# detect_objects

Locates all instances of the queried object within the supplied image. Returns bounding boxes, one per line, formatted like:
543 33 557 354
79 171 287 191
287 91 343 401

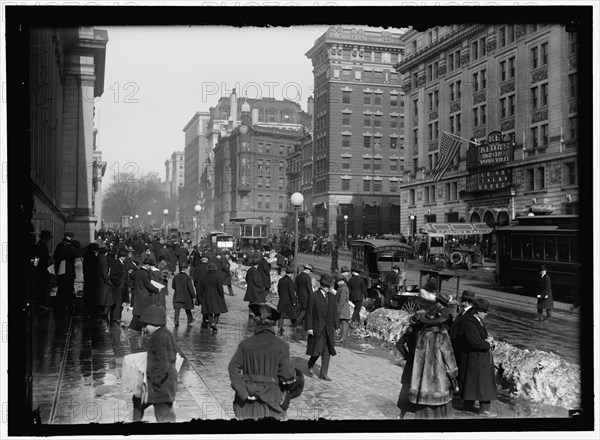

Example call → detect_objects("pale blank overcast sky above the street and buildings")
96 26 338 184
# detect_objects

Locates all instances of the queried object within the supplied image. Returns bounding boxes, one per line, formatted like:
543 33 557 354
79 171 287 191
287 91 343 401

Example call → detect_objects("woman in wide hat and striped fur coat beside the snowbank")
397 311 458 419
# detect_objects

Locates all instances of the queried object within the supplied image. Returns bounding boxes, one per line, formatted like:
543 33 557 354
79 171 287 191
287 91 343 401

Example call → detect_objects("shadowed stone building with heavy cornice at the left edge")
29 26 108 247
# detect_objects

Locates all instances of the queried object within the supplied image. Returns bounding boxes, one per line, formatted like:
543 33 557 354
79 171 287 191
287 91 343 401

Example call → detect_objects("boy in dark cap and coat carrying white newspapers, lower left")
133 304 177 423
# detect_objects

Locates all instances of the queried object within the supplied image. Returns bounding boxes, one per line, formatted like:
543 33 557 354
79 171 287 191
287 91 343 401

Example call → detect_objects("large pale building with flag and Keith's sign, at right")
396 24 579 237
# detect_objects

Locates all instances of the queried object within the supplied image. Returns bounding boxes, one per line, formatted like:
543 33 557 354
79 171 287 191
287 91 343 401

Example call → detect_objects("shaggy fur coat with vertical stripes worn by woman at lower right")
408 325 458 406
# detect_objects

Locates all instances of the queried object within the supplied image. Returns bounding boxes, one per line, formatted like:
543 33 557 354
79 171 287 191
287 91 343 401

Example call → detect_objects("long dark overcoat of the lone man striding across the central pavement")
304 289 340 356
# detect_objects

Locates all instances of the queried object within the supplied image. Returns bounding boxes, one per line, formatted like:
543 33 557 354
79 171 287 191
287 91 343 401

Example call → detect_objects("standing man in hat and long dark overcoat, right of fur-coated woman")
459 298 498 417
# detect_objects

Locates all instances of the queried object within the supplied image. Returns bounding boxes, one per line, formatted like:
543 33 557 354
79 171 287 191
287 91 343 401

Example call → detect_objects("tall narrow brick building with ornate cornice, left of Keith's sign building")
304 26 404 239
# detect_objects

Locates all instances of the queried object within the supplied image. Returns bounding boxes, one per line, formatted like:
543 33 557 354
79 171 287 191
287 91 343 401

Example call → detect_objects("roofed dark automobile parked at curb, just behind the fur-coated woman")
390 269 460 316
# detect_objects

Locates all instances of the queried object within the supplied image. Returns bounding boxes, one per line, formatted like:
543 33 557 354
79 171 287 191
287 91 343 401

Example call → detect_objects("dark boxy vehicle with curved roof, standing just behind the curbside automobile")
351 240 413 309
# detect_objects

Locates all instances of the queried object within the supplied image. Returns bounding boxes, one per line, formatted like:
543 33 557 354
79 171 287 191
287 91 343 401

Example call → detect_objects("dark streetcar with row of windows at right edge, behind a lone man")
495 215 581 303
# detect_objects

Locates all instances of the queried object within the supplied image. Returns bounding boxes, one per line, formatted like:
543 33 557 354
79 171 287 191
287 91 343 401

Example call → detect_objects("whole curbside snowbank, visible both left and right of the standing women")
361 308 581 409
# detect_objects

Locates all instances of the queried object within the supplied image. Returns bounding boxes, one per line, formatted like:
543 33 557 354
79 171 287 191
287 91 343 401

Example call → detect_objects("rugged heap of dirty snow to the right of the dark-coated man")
493 341 581 408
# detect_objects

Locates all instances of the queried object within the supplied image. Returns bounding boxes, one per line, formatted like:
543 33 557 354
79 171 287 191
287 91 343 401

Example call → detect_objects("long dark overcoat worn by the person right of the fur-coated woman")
459 315 498 401
